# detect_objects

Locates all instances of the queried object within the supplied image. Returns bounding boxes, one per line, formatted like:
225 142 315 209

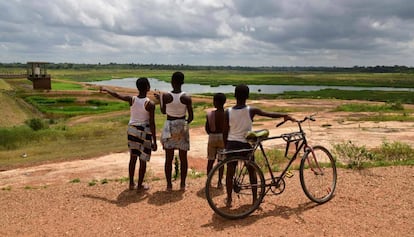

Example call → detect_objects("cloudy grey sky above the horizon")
0 0 414 67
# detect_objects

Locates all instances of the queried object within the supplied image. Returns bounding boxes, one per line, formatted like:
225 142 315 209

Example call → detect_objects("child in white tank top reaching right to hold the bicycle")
223 84 296 207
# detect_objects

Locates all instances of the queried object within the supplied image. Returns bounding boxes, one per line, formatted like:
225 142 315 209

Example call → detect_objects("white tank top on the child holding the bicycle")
227 106 253 142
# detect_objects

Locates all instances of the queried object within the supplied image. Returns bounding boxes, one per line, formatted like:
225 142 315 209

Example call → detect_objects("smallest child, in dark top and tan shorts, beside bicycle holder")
205 93 226 188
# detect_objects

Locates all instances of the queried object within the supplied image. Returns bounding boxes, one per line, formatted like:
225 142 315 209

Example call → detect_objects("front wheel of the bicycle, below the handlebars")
300 146 336 203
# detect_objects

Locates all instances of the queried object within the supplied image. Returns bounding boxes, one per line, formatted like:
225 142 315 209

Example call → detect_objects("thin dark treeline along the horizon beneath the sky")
0 63 414 73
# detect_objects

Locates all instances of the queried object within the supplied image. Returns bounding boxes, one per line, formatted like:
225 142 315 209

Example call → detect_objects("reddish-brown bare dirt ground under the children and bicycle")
0 100 414 236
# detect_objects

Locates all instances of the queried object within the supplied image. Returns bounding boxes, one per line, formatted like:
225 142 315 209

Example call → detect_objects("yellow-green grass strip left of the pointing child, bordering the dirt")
0 122 128 169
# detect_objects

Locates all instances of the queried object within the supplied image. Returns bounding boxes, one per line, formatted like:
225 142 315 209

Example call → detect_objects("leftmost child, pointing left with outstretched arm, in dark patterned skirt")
101 77 157 191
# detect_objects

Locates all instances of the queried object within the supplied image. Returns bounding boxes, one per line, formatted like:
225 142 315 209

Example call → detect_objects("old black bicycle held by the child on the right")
205 115 337 219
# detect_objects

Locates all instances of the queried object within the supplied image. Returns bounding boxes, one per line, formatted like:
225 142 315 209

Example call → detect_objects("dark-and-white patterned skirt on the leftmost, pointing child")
127 124 152 161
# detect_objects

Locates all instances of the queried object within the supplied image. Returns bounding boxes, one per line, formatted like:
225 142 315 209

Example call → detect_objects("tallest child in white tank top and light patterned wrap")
156 72 194 191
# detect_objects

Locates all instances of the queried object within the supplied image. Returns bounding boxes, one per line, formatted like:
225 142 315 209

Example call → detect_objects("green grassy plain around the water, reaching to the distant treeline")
0 66 414 170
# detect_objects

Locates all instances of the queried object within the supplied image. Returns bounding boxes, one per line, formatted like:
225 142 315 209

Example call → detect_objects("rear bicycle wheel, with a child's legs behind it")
205 157 265 219
